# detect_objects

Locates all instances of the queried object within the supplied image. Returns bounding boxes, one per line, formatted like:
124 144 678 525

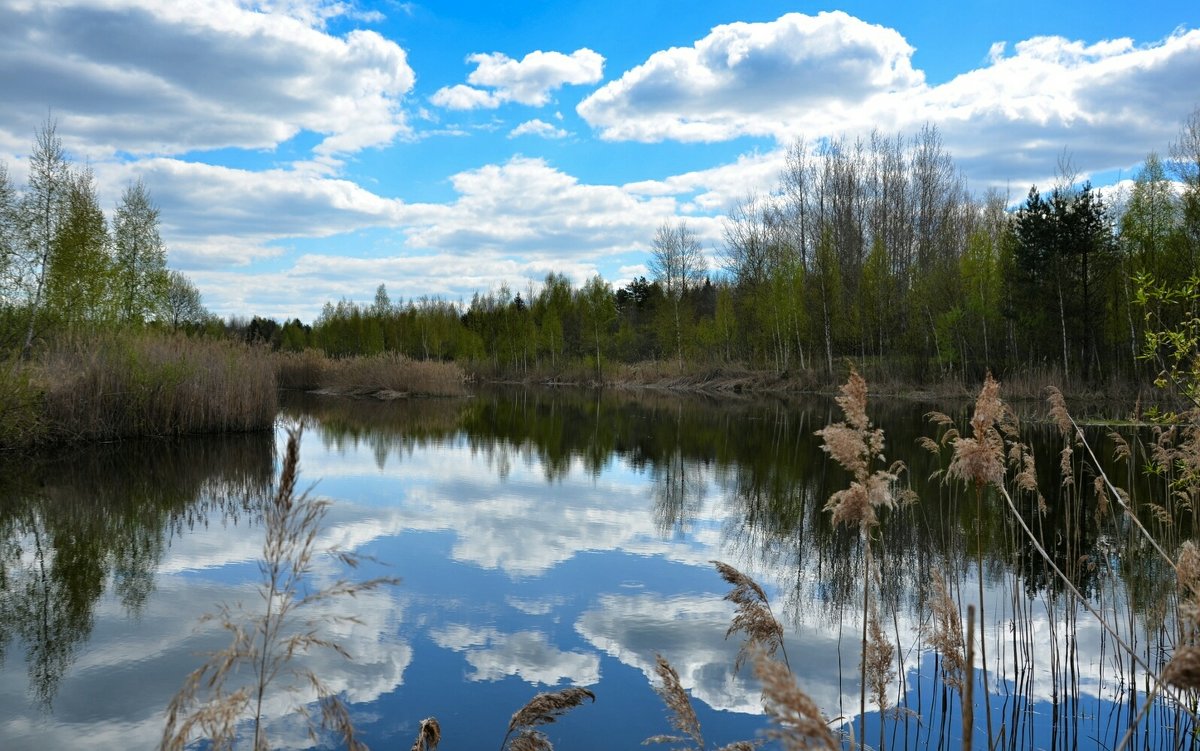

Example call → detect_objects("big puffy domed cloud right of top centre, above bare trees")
577 11 923 140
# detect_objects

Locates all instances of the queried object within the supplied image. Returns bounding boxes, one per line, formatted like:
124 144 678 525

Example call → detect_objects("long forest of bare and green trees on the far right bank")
257 109 1200 380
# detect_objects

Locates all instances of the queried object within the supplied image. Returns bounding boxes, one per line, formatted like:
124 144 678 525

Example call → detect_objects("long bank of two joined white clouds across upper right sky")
577 12 1200 187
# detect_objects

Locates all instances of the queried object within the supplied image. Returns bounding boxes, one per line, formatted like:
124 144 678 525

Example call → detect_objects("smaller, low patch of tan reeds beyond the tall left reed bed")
275 349 467 398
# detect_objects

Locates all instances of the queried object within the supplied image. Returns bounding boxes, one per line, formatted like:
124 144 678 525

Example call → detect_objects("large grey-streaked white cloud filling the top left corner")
0 0 414 158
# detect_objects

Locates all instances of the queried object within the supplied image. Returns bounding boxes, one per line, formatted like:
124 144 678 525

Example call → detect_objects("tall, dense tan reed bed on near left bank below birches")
0 332 278 449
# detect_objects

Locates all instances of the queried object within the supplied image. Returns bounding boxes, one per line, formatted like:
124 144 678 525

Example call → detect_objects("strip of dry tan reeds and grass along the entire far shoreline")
0 328 1177 450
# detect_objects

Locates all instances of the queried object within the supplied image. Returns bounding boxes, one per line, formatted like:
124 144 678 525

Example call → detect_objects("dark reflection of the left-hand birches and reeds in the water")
0 435 274 705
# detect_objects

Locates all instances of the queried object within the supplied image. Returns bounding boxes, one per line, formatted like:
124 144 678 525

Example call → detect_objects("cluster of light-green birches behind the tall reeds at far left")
0 121 209 356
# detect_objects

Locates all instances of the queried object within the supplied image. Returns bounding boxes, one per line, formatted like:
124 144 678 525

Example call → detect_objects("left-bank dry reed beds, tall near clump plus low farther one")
0 331 467 450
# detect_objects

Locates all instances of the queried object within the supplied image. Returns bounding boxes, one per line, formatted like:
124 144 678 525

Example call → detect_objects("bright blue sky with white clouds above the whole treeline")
0 0 1200 320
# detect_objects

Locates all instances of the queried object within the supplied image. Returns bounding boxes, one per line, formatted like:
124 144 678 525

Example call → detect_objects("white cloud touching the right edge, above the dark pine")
912 31 1200 185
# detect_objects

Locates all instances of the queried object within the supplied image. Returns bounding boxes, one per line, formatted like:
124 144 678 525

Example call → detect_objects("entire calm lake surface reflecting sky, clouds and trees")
0 389 1193 751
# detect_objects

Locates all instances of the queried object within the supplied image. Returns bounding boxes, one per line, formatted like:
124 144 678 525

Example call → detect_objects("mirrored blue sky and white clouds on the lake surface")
0 412 1185 750
